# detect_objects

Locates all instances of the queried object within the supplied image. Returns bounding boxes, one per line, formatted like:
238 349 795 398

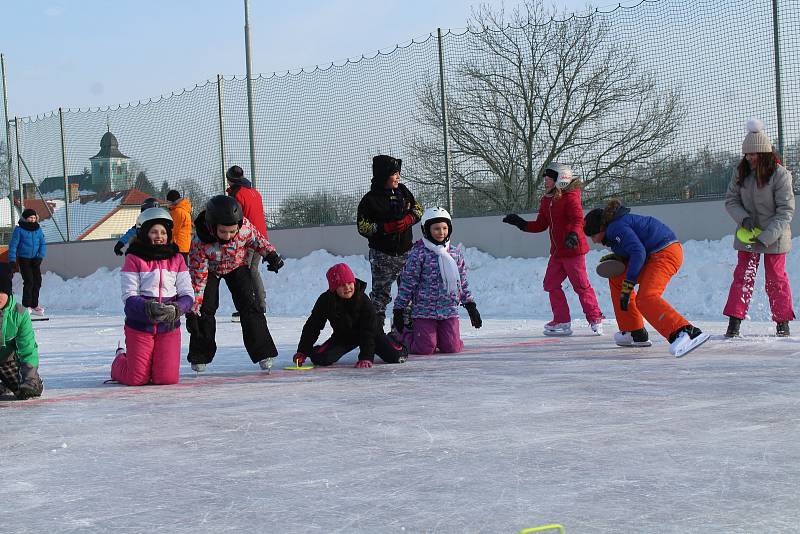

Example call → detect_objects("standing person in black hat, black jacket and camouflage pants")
357 155 423 330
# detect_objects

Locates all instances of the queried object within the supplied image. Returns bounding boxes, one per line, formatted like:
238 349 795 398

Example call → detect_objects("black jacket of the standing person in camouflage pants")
357 182 422 256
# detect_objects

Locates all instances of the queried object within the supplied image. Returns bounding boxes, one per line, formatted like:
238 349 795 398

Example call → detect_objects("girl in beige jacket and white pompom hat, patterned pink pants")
723 120 794 337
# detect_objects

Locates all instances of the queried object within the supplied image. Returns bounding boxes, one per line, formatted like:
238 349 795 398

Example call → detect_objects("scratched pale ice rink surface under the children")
0 315 800 534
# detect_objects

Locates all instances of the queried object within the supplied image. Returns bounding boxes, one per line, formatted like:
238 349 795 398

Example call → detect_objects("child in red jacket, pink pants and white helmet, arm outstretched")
503 163 603 336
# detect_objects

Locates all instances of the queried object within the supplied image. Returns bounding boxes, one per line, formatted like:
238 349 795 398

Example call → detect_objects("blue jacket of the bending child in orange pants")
603 206 678 283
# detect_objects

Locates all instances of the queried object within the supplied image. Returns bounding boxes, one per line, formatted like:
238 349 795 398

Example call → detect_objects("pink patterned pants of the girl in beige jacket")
722 251 794 322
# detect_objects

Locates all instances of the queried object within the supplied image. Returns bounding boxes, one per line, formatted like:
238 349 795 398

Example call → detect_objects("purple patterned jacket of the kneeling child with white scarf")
394 239 473 320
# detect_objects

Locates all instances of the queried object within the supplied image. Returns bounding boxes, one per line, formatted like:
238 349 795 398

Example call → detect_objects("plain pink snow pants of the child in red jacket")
543 254 603 323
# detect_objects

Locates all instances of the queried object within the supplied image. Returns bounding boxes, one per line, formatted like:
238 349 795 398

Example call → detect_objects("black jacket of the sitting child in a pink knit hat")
297 278 377 361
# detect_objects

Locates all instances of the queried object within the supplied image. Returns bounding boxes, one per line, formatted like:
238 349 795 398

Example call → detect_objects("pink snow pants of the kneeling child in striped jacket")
111 326 181 386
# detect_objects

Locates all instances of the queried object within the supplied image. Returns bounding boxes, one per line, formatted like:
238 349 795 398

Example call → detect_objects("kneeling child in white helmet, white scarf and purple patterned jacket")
394 208 483 354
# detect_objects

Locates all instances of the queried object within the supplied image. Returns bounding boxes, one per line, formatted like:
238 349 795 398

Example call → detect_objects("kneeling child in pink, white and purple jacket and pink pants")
111 208 194 386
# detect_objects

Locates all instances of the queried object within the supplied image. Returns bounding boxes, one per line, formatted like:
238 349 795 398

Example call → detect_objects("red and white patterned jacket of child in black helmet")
189 211 276 313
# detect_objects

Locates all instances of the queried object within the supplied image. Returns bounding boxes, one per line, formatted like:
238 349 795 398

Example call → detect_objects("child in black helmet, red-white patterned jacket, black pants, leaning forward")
186 195 283 372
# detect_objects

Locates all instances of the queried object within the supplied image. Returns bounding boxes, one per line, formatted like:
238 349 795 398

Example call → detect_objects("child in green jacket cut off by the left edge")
0 263 43 399
